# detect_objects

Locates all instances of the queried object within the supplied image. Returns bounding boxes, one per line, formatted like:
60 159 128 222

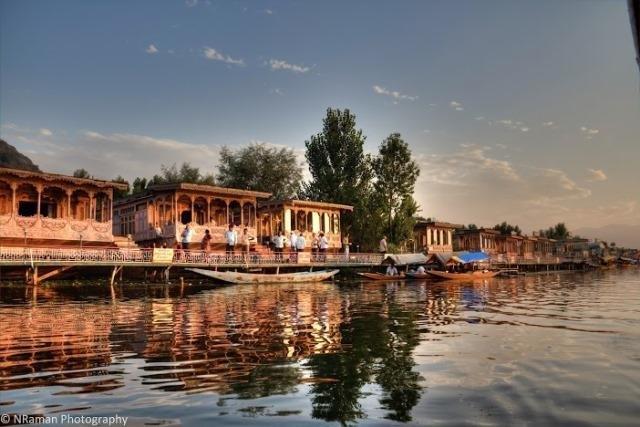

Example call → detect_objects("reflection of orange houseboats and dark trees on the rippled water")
0 283 470 424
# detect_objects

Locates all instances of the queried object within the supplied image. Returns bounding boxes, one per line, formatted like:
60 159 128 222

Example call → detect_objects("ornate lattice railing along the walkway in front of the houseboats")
0 247 382 266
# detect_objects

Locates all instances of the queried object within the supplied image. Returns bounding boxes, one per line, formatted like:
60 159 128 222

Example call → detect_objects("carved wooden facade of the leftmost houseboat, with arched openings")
0 168 127 246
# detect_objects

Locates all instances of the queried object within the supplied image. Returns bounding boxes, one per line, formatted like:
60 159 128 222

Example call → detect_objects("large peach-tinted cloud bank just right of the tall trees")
415 144 591 229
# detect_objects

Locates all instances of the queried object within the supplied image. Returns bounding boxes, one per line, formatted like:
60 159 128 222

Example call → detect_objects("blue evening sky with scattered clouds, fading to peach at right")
0 0 640 246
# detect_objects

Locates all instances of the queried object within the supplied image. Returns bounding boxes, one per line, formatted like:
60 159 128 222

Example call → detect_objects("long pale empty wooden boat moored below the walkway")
187 268 340 284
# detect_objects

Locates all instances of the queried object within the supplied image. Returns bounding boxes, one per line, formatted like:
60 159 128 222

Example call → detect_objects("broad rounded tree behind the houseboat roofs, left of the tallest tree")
217 144 302 199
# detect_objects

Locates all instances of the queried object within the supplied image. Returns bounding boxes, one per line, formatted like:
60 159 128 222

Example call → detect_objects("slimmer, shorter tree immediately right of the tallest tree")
373 133 420 244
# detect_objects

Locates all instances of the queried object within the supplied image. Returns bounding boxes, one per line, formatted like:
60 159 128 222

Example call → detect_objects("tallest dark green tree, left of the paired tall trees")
304 108 380 249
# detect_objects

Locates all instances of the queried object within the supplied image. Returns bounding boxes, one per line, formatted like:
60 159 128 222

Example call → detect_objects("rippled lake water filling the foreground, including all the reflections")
0 269 640 426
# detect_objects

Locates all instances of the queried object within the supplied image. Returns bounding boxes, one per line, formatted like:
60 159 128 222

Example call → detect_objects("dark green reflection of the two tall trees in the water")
307 303 421 425
